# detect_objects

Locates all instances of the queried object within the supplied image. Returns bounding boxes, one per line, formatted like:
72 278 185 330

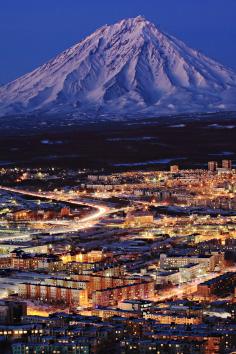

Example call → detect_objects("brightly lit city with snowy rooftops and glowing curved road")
0 162 236 354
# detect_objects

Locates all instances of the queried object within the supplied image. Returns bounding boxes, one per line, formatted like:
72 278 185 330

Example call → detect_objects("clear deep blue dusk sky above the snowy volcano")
0 0 236 83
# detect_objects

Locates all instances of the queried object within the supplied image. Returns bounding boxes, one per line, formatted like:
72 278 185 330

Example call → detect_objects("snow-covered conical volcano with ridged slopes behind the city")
0 16 236 115
